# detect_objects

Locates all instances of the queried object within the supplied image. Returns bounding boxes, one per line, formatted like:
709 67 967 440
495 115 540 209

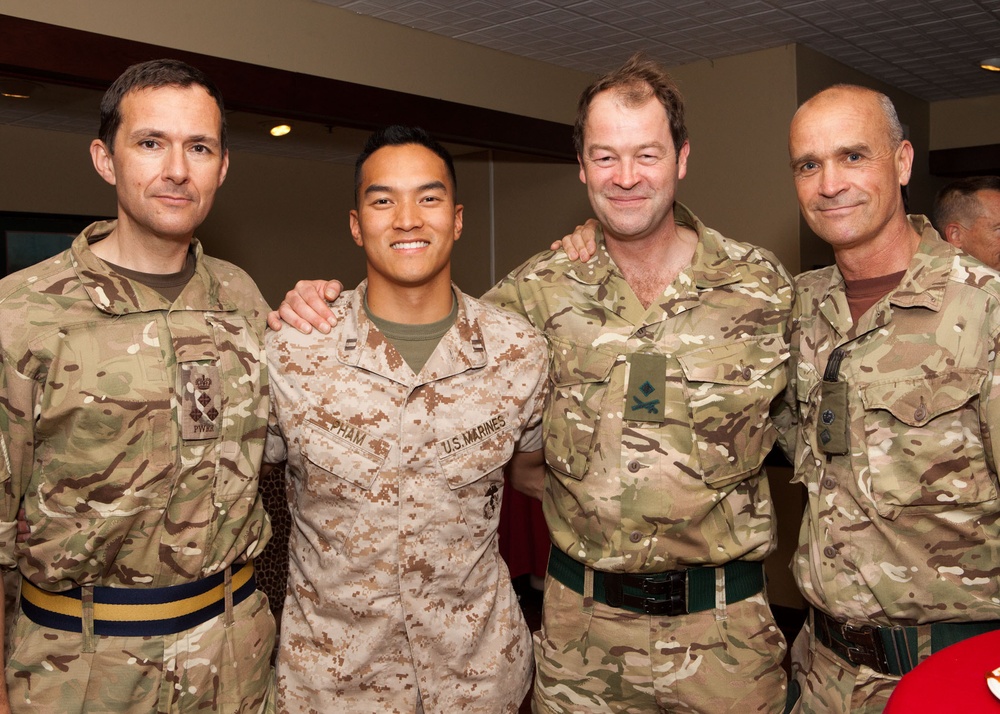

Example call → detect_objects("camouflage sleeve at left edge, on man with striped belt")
0 346 37 567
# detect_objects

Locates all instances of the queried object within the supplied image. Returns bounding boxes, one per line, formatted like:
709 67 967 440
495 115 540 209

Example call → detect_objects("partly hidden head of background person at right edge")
933 176 1000 270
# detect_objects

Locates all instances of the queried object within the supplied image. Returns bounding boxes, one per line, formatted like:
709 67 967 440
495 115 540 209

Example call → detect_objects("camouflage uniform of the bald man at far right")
778 216 1000 712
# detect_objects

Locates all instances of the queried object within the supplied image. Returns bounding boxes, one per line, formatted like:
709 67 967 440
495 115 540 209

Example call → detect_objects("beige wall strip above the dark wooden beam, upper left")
0 0 592 123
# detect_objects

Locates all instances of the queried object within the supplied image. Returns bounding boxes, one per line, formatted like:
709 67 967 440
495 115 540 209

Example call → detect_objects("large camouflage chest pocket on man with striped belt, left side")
35 318 177 518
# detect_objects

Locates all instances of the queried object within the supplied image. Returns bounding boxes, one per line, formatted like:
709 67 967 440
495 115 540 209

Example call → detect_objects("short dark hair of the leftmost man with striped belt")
97 59 228 154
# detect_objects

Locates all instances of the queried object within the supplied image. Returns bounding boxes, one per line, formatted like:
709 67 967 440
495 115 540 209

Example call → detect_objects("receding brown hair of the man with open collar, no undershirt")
573 52 687 157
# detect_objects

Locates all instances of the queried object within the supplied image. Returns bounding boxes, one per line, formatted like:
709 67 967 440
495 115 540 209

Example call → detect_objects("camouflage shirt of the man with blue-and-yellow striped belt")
0 221 270 590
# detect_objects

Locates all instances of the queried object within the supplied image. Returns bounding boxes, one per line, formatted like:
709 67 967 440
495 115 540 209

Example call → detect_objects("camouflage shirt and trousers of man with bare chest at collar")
486 203 793 714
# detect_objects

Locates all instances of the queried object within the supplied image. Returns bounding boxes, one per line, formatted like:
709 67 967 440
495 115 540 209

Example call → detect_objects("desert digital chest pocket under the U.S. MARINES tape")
440 429 515 548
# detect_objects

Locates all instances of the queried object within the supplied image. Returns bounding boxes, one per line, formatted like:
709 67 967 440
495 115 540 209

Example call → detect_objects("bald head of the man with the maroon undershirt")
788 85 913 263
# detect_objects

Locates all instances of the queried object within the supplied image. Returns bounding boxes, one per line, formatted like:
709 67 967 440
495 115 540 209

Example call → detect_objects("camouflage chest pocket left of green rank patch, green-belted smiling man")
545 337 618 480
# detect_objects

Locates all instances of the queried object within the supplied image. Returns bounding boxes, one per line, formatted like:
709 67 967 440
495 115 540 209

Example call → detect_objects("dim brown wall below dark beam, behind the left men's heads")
0 125 589 305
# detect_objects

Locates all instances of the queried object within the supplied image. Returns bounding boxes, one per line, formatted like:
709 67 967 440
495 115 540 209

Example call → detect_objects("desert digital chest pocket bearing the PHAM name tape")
292 421 388 553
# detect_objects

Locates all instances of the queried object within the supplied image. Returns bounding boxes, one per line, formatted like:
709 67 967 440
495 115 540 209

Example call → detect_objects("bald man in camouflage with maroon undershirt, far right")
779 86 1000 714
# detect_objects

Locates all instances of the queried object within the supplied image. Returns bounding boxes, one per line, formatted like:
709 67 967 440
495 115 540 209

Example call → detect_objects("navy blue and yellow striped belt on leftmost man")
21 561 257 637
